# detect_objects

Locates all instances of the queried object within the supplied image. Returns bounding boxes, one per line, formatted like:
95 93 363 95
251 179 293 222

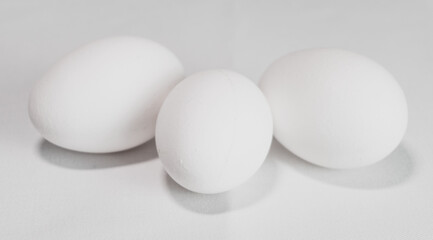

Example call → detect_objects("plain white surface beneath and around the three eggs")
0 0 433 240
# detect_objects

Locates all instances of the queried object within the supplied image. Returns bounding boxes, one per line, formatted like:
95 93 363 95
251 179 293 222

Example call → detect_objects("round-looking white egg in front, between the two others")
155 70 272 193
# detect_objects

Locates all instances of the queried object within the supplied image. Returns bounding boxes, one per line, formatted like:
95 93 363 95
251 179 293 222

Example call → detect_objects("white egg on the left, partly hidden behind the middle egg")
28 36 184 153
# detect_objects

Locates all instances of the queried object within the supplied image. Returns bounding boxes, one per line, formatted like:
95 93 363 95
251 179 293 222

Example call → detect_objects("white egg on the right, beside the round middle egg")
260 49 408 169
